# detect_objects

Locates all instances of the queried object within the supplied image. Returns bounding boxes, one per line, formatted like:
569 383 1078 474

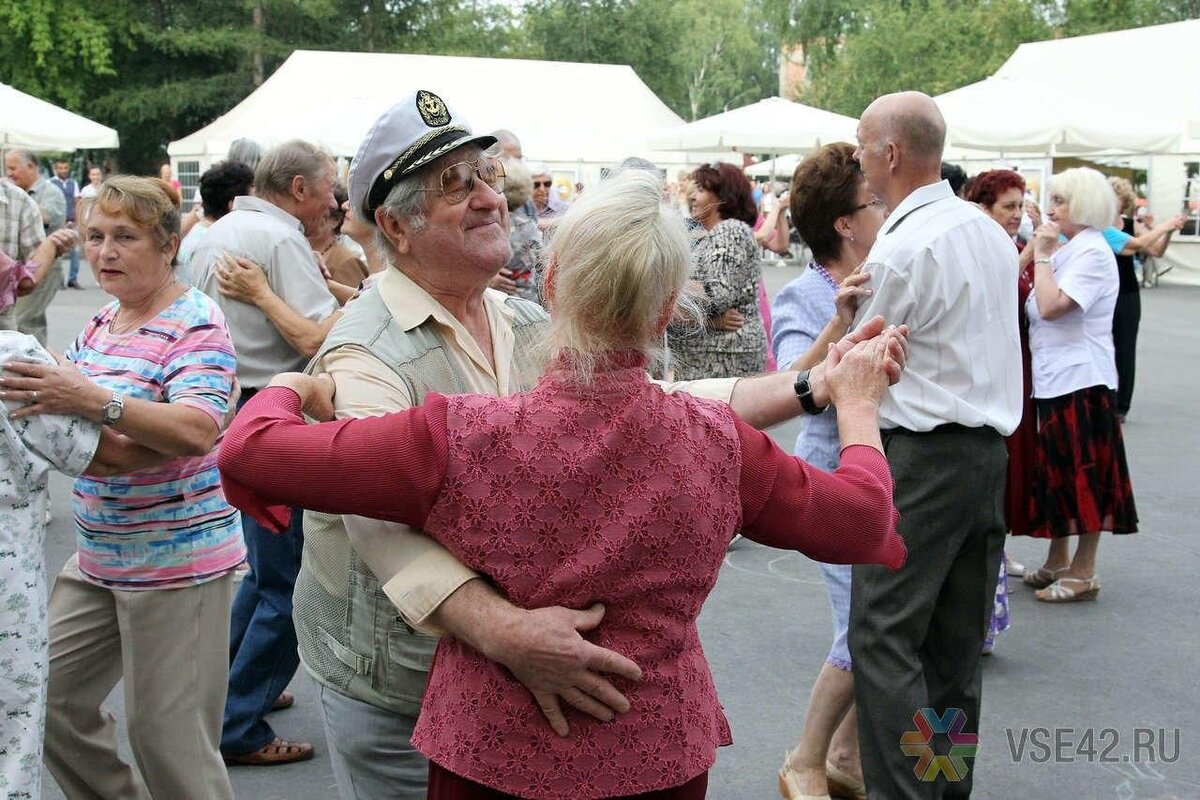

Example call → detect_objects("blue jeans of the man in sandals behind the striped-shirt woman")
221 509 304 756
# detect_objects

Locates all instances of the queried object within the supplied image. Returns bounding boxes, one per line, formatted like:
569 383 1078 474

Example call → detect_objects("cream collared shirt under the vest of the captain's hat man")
320 269 737 633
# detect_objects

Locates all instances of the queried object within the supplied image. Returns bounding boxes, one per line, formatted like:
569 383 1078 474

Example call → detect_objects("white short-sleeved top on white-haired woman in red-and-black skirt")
1025 228 1121 398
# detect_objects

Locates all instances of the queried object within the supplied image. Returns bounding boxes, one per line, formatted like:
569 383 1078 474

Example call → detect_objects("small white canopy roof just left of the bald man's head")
650 97 858 154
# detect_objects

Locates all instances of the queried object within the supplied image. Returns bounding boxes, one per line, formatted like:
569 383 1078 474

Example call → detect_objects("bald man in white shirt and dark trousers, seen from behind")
850 92 1021 800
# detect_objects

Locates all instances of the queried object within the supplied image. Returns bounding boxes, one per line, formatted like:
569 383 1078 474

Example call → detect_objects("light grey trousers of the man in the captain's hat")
317 684 430 800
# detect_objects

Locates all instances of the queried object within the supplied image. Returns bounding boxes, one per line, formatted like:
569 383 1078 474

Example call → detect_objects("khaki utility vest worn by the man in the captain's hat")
293 289 550 717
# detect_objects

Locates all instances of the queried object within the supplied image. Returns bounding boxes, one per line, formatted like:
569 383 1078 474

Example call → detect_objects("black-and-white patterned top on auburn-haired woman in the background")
667 219 767 380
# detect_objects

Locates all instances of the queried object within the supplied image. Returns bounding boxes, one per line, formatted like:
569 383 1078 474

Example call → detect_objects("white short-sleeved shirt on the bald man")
856 181 1021 435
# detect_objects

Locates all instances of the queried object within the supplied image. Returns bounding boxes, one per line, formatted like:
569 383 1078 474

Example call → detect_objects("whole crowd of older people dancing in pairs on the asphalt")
0 82 1161 800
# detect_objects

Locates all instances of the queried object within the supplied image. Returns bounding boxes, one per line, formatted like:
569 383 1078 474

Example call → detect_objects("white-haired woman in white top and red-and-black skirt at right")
1025 167 1138 603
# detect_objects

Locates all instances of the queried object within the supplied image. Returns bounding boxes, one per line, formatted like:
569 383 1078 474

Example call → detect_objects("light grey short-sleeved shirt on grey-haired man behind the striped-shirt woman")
188 196 337 389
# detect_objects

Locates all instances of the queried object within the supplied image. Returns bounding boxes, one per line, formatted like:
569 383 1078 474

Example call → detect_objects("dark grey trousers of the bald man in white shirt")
850 426 1008 800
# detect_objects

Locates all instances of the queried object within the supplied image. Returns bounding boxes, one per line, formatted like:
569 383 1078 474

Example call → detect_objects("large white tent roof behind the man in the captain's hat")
174 50 682 164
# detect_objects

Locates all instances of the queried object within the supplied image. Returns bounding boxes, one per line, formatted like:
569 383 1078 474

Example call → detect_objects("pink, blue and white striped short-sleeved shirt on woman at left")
67 288 245 590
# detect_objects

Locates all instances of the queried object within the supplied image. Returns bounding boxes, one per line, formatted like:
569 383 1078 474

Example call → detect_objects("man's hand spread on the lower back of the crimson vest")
488 603 642 736
